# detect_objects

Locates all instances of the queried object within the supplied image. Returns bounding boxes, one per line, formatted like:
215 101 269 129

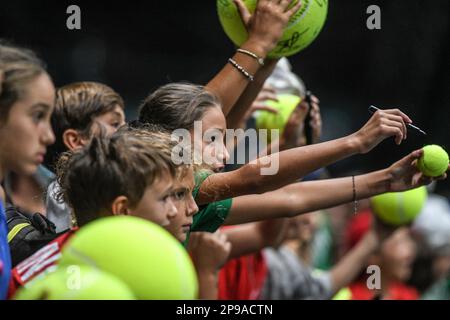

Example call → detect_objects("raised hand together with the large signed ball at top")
217 0 328 58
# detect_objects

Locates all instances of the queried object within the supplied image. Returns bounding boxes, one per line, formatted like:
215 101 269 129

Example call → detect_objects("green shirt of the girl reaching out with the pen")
185 171 232 245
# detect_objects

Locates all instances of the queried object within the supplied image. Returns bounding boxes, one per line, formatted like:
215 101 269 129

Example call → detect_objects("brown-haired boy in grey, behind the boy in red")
45 82 125 232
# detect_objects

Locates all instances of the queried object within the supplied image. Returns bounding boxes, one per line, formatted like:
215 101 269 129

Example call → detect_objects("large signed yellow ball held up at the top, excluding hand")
217 0 328 58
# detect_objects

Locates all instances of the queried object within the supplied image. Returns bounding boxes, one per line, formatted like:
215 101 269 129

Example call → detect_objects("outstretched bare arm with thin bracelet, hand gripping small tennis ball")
225 149 446 225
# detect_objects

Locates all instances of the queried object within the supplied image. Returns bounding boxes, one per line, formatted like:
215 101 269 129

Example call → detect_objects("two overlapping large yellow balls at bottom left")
15 216 198 300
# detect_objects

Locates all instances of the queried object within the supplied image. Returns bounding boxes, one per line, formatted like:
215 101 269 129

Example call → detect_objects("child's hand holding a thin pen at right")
354 109 412 153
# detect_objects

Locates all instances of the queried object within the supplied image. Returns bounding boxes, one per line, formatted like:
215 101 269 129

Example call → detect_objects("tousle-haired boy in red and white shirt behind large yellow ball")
13 128 229 300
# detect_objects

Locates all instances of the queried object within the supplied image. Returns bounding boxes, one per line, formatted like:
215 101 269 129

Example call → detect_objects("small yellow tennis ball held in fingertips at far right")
417 144 449 177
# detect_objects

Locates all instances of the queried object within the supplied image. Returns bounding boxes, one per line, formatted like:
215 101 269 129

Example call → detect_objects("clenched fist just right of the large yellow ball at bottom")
188 231 231 274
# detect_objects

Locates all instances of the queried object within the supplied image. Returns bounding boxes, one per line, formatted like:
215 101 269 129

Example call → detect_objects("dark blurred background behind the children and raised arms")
0 0 450 191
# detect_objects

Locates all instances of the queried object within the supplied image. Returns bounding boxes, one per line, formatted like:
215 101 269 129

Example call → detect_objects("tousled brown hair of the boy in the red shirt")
57 128 183 226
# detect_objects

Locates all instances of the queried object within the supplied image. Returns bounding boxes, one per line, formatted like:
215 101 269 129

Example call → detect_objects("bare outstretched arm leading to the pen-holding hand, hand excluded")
195 136 358 205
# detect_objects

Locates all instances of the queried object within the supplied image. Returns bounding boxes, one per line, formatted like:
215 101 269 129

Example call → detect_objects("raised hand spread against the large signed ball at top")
234 0 301 56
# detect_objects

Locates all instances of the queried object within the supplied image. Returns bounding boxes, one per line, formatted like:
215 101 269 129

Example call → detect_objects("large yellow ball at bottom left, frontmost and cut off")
15 265 135 300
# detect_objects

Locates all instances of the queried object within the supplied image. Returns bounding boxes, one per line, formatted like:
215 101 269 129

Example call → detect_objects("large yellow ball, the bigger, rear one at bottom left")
59 216 198 300
